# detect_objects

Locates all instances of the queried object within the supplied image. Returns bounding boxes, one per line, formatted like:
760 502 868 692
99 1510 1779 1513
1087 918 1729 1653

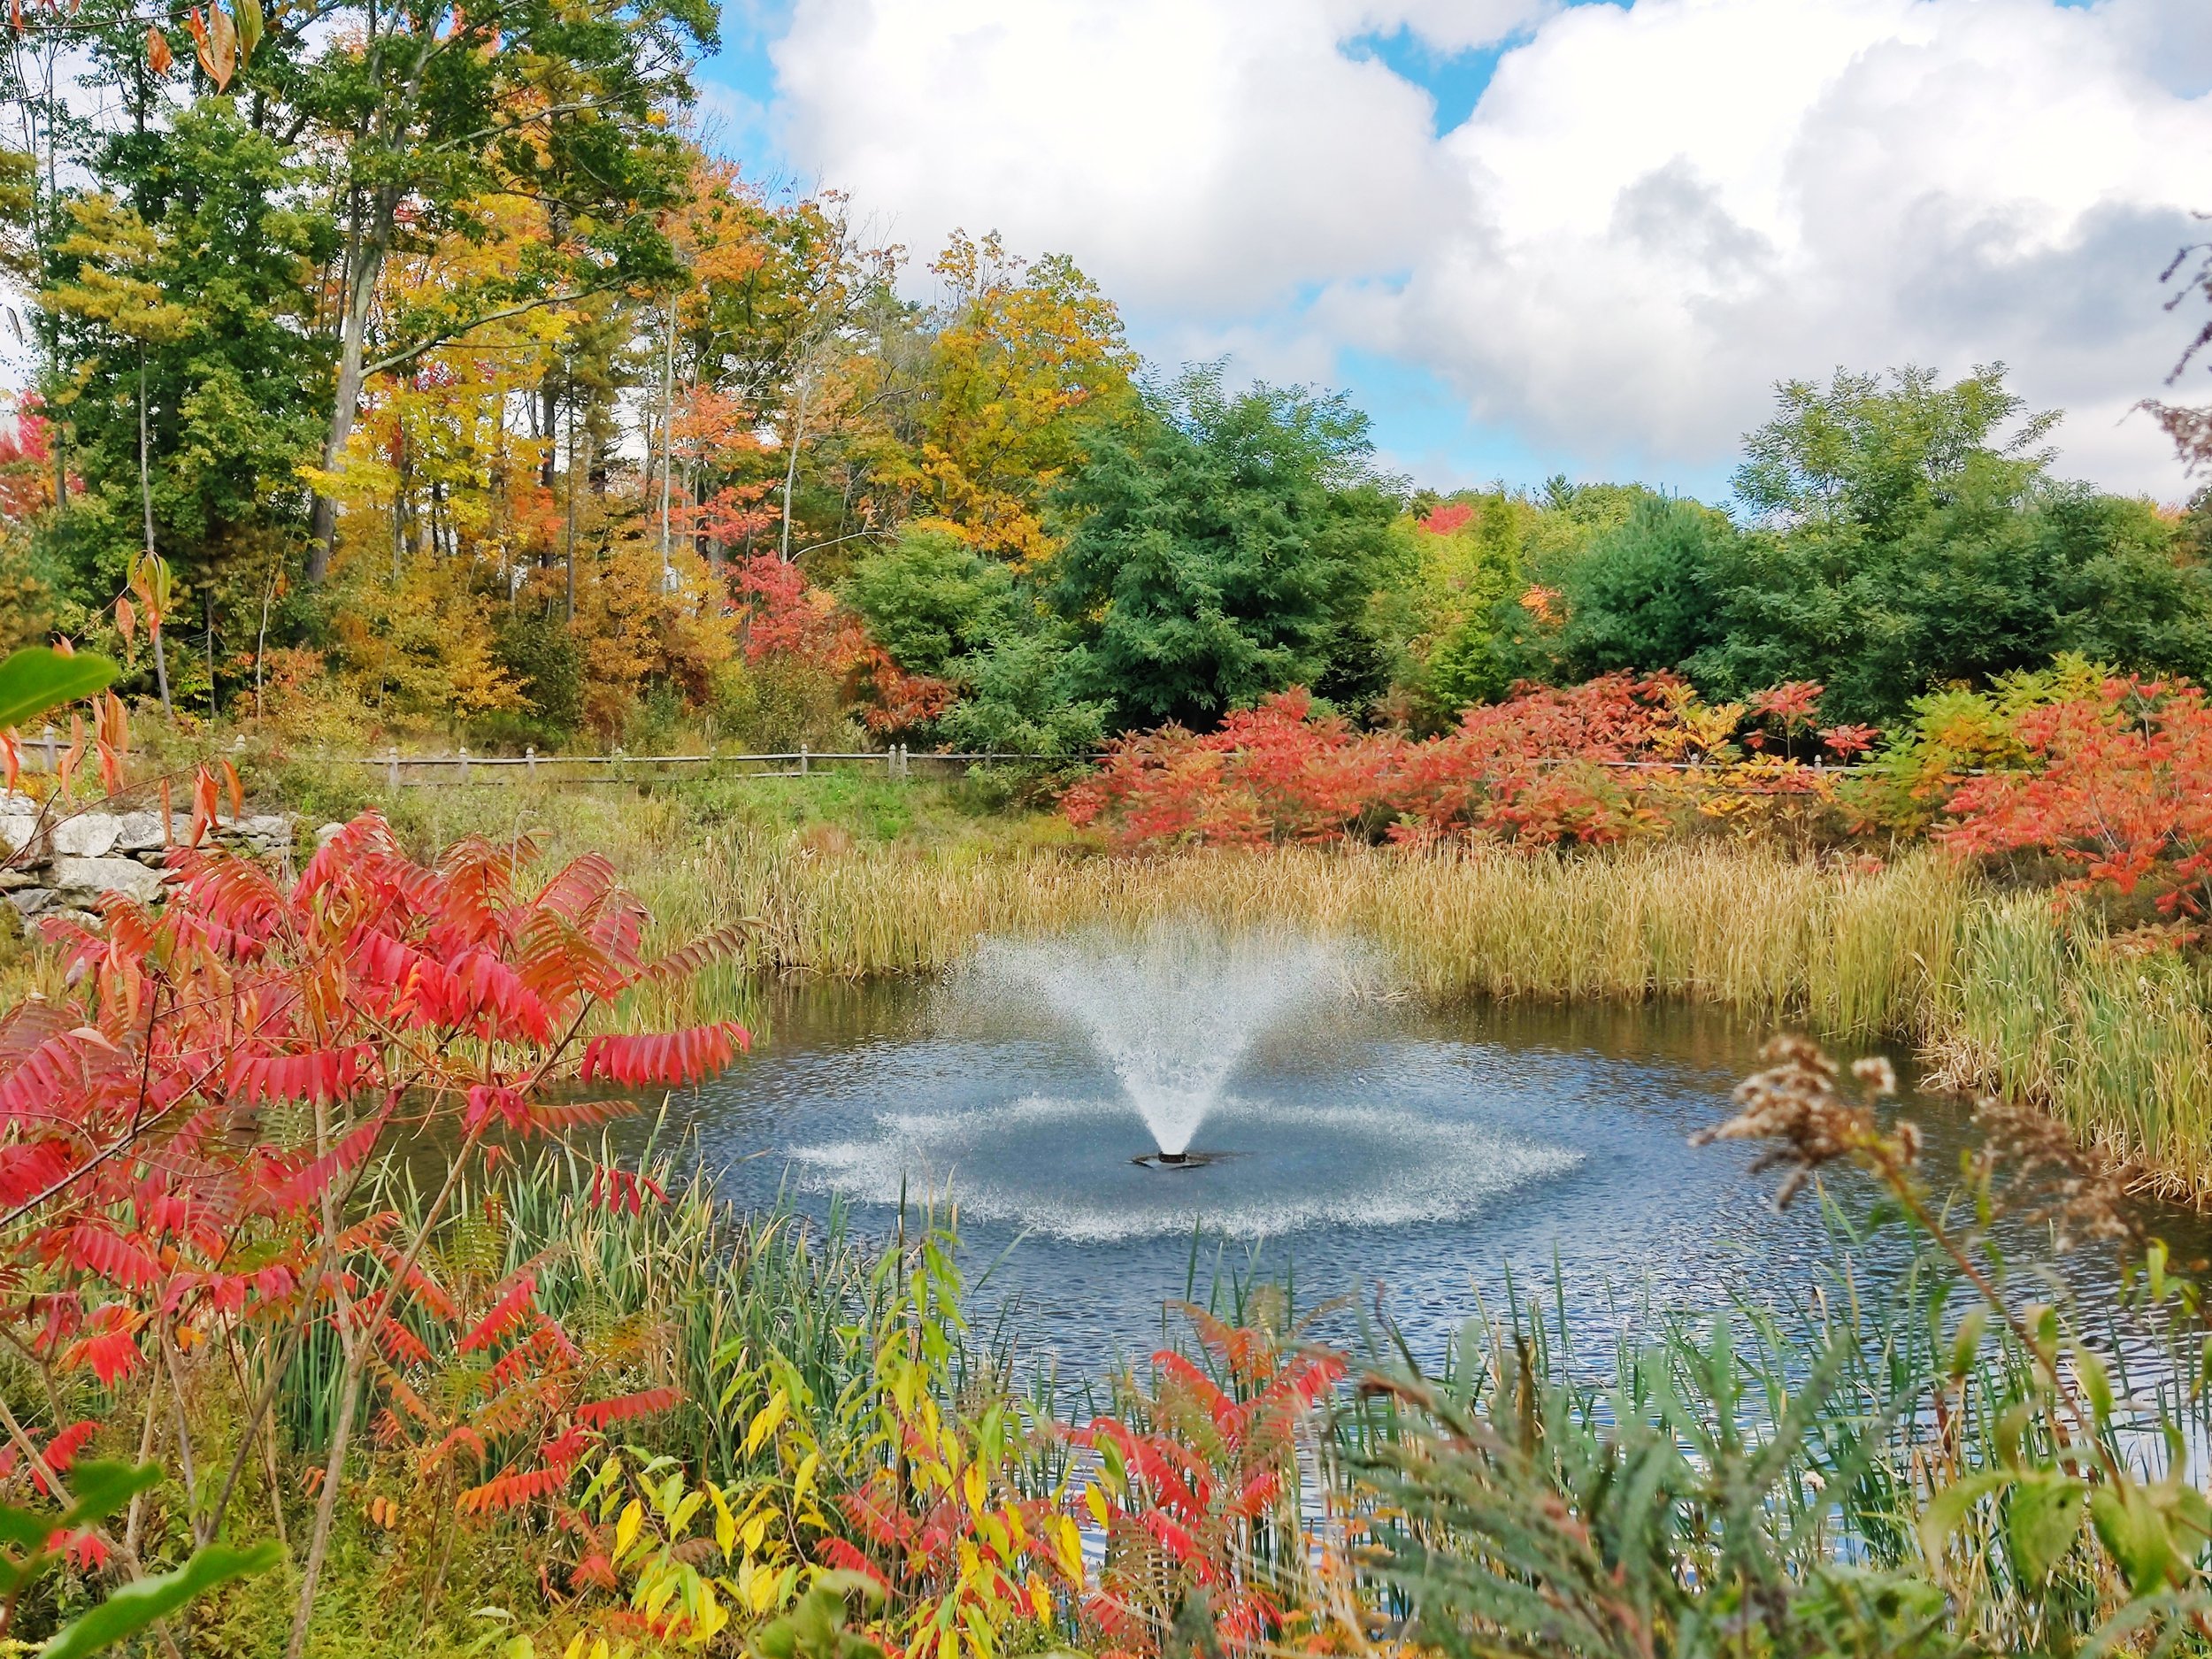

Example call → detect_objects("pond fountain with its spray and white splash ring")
781 925 1579 1241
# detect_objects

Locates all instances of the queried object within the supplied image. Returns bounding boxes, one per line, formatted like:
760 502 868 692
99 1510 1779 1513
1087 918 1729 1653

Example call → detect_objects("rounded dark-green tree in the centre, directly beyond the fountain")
1047 367 1398 730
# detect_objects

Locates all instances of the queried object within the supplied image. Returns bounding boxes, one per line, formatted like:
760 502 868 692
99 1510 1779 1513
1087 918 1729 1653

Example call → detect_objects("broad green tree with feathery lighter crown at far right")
1690 367 2212 724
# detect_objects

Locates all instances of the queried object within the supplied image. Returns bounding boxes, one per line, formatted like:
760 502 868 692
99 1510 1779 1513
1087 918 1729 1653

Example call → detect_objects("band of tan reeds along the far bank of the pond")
372 786 2212 1199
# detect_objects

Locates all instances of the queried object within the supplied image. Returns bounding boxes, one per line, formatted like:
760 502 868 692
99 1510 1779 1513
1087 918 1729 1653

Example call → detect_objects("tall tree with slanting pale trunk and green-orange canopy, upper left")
270 0 715 580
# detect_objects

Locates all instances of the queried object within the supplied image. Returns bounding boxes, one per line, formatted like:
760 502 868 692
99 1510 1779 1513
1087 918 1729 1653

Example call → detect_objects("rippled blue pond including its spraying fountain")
646 941 2206 1374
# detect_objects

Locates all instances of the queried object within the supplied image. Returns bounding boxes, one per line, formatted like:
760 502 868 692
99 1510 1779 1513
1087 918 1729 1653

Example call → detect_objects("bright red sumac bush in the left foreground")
0 814 743 1653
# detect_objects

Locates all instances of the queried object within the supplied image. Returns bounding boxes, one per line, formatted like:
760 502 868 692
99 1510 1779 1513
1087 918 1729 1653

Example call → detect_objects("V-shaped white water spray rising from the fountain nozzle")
976 925 1361 1168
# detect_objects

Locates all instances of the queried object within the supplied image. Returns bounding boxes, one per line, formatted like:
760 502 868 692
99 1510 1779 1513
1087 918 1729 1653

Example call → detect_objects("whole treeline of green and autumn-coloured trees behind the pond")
0 0 2212 755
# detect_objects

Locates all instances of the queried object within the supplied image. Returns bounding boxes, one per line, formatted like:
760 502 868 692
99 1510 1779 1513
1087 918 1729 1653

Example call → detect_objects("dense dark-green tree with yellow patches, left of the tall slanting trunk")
42 97 336 650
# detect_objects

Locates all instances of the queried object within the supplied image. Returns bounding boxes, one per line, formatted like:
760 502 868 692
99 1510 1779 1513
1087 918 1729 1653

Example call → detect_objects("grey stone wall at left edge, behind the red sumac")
0 792 296 920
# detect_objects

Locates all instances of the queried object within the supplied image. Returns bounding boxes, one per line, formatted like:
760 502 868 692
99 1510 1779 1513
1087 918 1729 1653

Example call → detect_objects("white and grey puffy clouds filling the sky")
774 0 2212 495
